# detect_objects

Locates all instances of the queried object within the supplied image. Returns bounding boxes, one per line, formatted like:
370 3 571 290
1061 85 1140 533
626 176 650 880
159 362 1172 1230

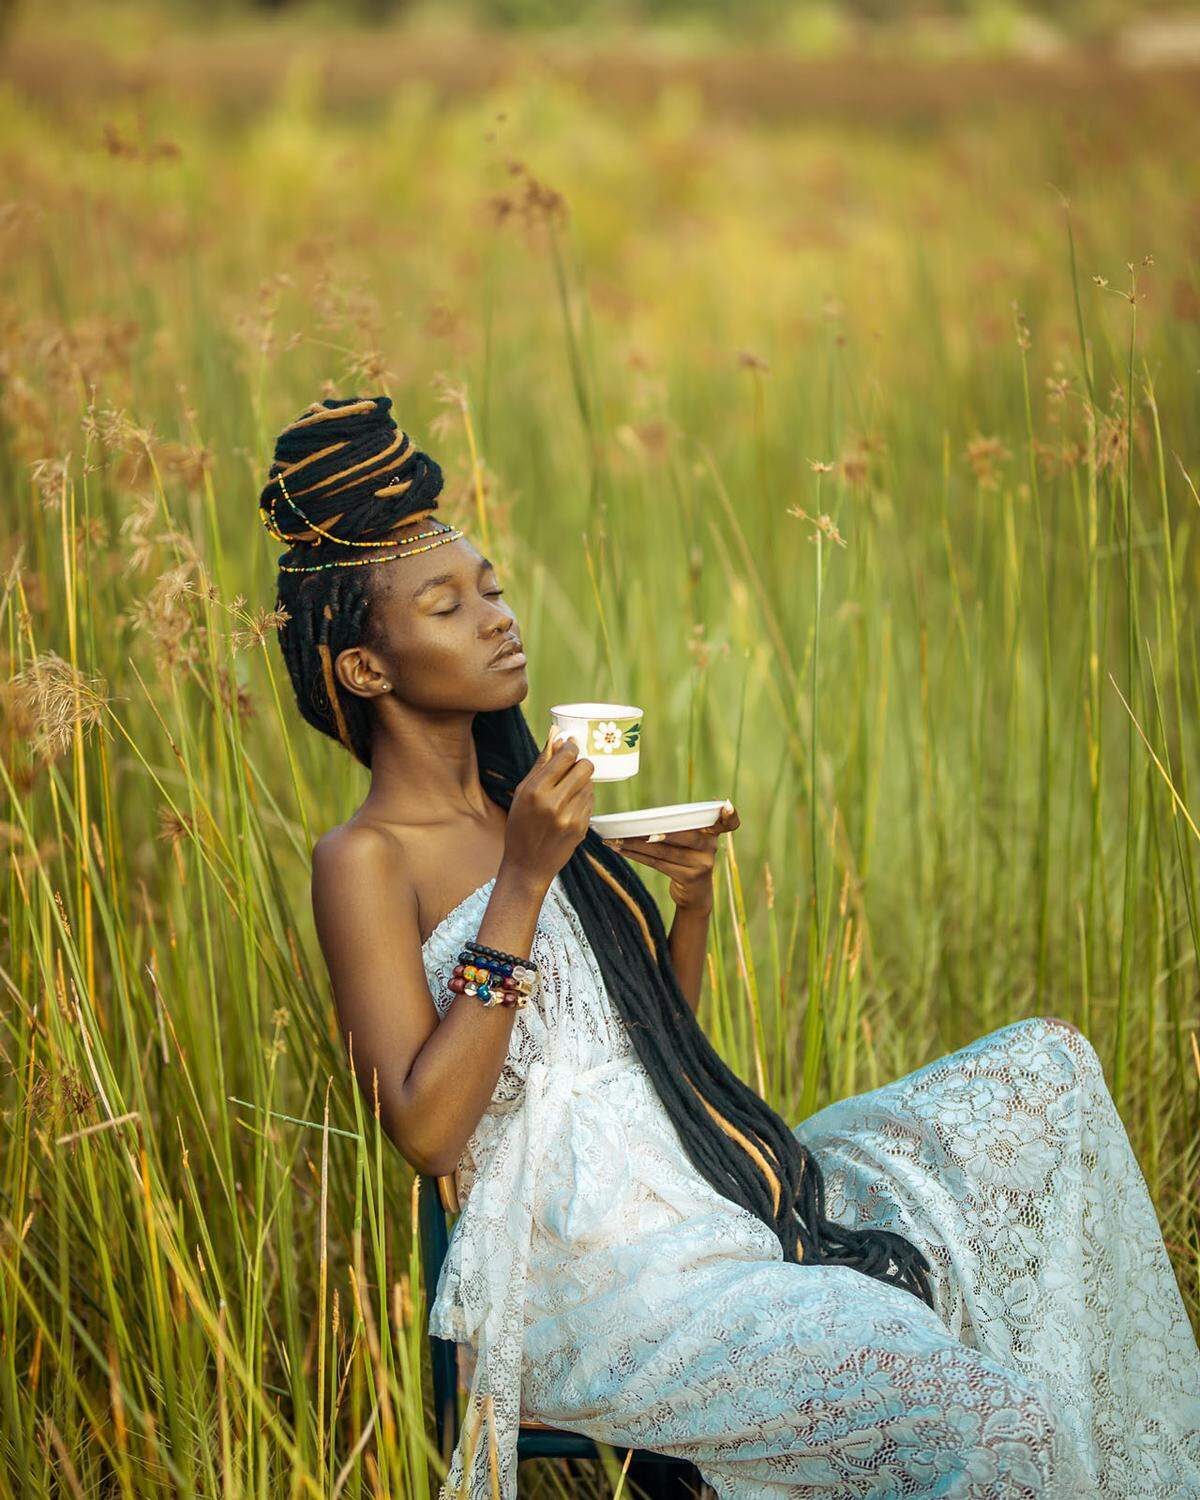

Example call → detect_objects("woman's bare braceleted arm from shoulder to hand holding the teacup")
312 740 594 1176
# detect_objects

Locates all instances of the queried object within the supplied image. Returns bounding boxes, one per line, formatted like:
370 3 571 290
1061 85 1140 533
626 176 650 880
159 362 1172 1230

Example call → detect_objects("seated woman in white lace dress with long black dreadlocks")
261 398 1200 1500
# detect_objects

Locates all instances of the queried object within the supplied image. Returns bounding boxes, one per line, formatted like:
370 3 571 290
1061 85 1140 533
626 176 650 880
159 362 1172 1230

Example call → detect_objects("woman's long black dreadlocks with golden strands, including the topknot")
260 396 933 1307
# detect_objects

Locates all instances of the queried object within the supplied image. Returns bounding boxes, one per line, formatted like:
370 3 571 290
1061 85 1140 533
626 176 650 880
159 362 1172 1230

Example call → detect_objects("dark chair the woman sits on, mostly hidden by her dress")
419 1175 704 1500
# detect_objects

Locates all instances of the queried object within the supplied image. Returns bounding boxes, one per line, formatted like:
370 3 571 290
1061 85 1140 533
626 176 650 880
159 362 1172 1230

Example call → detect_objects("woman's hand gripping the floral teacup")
504 728 596 884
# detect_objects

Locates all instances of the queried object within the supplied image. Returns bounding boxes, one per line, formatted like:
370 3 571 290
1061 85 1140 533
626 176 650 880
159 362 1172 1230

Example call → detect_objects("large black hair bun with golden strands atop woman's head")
258 396 444 546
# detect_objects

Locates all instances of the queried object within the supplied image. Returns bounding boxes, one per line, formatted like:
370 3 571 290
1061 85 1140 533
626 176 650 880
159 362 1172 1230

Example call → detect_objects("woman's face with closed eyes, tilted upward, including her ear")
339 518 530 711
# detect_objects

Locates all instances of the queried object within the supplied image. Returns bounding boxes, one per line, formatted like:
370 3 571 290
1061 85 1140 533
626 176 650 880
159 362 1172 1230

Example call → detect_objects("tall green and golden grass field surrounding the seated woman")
0 5 1200 1500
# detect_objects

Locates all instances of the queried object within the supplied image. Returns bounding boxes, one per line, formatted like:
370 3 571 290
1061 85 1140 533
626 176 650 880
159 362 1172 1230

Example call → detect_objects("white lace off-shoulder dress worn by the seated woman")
423 876 1200 1500
